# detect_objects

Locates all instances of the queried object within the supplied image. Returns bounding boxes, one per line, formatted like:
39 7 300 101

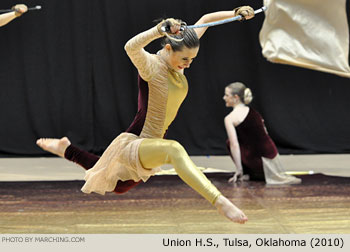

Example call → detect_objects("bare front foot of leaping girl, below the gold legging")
215 195 248 224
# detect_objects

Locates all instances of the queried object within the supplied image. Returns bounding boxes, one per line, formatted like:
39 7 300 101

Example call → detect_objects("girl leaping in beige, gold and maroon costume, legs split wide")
37 6 254 223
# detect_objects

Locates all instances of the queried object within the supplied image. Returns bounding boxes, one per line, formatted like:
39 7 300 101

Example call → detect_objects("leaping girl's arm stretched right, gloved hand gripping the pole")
195 6 254 38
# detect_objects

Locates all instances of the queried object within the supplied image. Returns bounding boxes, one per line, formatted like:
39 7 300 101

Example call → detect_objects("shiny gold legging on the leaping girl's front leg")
139 138 221 204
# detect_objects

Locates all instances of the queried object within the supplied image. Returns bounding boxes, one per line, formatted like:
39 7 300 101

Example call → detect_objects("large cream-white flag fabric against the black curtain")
260 0 350 78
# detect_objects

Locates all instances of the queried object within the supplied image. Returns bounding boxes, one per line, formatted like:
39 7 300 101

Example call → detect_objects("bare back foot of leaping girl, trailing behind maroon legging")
36 137 71 157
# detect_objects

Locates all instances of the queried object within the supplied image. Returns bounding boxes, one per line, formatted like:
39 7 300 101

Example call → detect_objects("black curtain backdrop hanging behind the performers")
0 0 350 156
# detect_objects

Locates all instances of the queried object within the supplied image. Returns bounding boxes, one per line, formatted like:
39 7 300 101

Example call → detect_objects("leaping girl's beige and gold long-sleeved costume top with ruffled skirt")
82 27 188 194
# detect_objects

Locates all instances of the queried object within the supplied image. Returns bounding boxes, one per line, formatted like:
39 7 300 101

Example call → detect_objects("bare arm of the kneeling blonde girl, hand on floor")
225 115 243 182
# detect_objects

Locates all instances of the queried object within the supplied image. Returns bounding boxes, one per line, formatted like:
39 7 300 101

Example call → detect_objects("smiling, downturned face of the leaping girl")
167 44 199 71
